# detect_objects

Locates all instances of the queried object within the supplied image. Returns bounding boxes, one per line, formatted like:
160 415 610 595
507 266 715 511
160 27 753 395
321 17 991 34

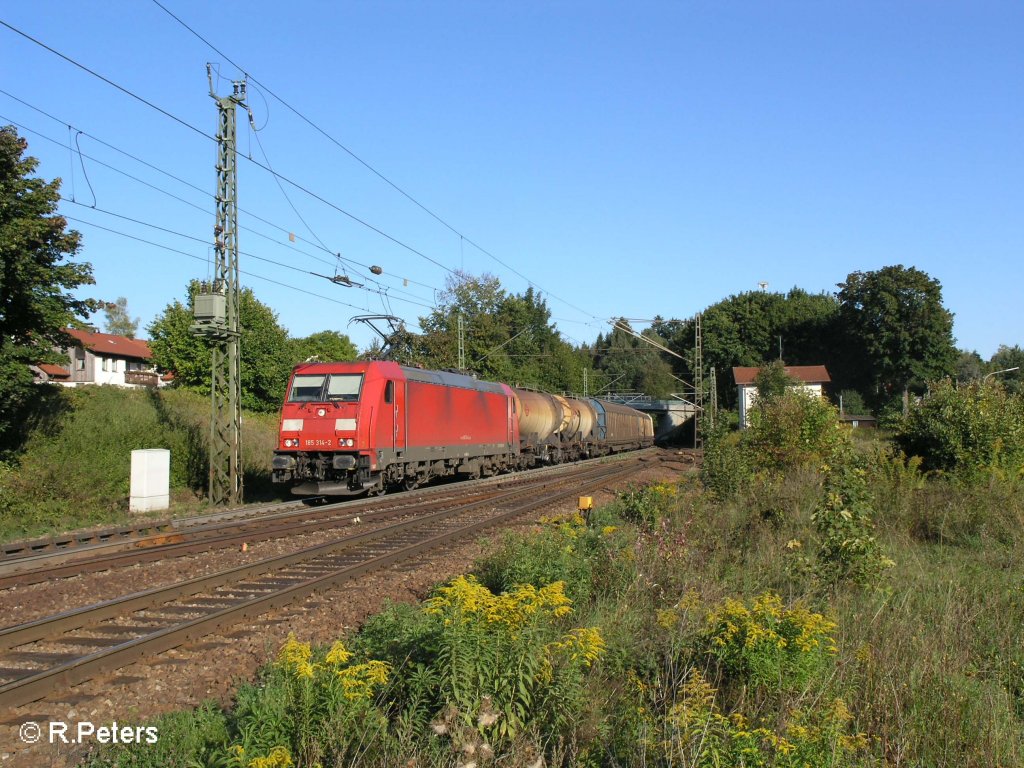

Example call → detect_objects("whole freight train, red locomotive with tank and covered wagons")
272 361 654 496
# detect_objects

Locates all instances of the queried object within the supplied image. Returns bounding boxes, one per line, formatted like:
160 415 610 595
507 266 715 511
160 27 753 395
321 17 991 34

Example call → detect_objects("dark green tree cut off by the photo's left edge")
0 126 98 451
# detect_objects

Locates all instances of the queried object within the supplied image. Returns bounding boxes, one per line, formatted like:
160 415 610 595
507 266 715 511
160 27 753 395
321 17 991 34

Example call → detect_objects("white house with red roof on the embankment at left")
33 328 167 387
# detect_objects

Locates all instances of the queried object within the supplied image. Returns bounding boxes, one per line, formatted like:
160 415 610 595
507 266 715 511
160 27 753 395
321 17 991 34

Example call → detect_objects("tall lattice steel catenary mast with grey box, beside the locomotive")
191 65 246 505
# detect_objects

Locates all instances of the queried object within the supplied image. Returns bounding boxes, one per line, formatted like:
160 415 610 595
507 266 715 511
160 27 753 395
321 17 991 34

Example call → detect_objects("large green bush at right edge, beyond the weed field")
896 379 1024 481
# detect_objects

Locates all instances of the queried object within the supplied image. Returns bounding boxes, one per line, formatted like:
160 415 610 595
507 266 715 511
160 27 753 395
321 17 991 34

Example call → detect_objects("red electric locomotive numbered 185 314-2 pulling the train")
272 362 519 496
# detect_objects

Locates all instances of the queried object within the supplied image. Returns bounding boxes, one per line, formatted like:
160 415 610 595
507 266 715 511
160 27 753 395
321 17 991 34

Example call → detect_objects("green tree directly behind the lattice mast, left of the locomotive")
147 281 292 412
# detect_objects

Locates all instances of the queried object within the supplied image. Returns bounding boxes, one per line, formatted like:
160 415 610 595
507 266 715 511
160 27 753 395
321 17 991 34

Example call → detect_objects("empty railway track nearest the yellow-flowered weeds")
0 456 643 709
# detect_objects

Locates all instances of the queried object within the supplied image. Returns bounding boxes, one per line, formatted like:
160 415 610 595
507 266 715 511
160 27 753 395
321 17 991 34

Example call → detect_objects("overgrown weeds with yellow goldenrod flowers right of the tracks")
77 382 1024 768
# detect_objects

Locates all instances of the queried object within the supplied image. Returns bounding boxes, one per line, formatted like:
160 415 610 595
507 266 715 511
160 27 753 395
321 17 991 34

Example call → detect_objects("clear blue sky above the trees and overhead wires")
0 0 1024 357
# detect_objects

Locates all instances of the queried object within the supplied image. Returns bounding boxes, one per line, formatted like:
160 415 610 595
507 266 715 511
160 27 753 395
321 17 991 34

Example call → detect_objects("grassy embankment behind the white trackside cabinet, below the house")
0 387 276 540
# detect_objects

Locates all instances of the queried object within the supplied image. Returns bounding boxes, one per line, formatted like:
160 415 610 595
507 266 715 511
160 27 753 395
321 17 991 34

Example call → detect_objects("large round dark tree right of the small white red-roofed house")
839 264 956 414
